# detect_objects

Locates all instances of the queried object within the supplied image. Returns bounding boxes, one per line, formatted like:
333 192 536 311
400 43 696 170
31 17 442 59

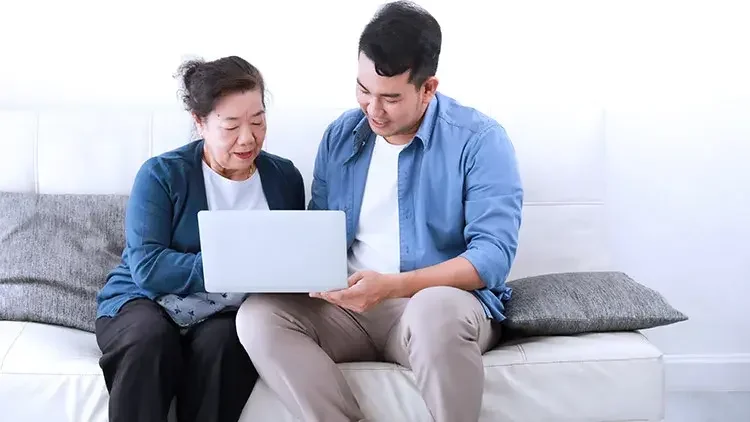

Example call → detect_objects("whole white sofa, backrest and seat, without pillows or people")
0 107 664 422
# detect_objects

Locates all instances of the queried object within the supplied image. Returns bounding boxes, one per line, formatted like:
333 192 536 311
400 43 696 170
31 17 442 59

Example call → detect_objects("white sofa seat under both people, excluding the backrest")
0 321 664 422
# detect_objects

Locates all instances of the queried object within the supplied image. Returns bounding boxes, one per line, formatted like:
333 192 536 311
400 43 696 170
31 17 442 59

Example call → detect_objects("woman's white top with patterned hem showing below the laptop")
156 162 269 327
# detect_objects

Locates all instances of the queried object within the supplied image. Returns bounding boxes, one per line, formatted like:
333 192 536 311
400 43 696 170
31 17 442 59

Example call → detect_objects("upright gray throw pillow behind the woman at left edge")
0 192 127 332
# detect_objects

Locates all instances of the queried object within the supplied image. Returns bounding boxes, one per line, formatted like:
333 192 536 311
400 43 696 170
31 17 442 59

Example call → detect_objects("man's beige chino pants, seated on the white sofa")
237 287 500 422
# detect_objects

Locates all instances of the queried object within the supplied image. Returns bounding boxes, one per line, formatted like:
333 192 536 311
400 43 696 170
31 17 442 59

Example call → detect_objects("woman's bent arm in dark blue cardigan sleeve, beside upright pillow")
125 159 205 295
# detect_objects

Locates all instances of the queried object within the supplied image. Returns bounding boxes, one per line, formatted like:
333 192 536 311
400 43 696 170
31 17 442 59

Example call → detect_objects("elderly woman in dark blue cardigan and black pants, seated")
96 57 305 422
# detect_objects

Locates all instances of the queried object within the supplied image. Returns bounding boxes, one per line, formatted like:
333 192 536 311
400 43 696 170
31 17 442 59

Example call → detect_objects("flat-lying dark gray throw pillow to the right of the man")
503 272 687 336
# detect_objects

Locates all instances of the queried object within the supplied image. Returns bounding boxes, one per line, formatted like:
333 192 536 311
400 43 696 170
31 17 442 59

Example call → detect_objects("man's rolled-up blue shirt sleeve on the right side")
461 125 523 290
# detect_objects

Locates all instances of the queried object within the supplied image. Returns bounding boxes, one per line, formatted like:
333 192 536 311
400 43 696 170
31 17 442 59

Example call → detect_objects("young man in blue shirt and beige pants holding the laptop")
237 2 523 422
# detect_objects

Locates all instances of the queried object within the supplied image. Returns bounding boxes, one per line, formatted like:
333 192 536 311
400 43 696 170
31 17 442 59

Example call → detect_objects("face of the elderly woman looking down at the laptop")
196 90 266 180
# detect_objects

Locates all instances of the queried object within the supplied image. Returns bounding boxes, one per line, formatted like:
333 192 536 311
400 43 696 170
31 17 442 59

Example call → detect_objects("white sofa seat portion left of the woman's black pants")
0 321 107 422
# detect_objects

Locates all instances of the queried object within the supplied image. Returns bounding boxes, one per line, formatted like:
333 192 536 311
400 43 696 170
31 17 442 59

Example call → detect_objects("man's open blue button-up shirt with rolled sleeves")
308 93 523 321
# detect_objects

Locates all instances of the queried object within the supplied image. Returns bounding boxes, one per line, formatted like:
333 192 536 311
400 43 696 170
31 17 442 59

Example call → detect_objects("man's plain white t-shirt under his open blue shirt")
349 136 409 275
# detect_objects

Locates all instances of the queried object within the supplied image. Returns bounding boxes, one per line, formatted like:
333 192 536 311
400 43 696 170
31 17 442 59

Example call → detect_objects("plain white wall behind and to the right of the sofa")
0 0 750 389
